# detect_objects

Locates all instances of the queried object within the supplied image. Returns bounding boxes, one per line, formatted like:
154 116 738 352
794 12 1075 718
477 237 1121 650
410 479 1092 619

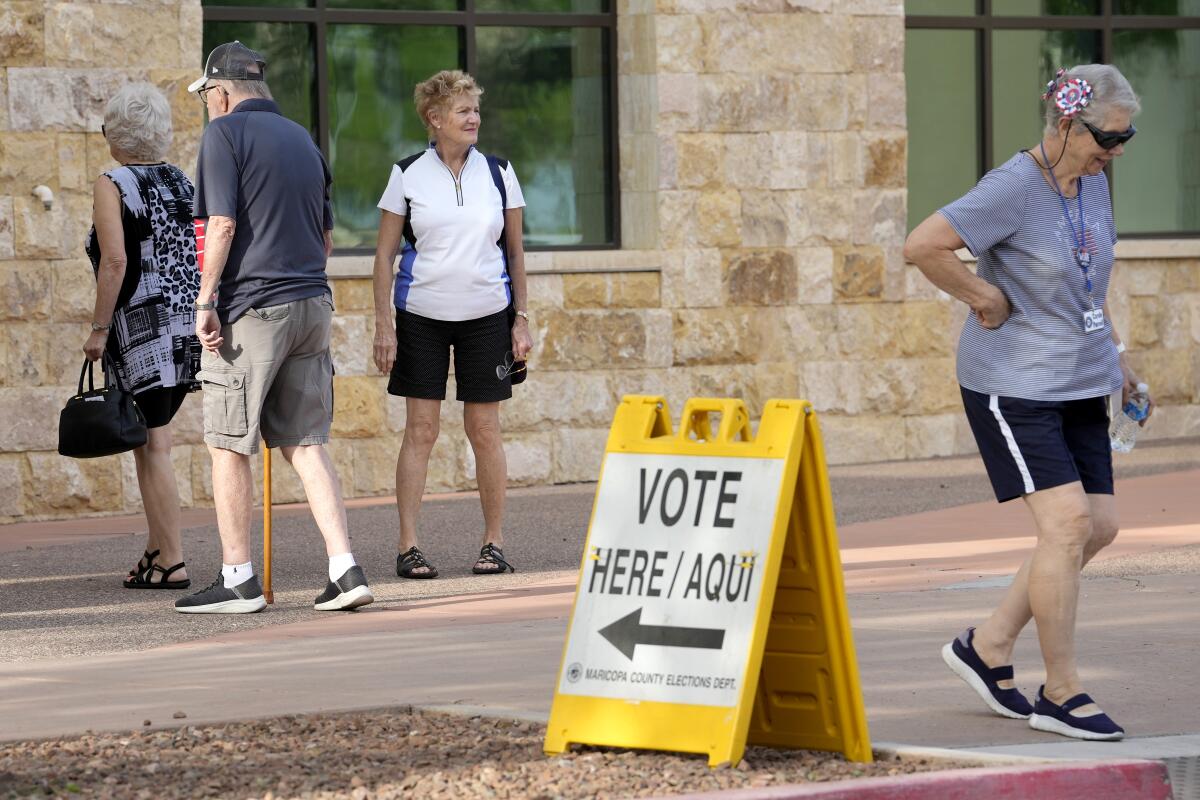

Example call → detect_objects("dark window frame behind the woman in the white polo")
202 0 620 255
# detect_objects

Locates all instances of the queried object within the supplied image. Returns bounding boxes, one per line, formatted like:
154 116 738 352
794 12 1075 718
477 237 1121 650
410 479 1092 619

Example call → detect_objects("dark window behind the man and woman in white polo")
204 0 619 253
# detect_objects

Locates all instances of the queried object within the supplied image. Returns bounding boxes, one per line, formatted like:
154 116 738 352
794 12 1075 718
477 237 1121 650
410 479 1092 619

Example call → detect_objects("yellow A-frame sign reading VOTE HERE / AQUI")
545 396 871 765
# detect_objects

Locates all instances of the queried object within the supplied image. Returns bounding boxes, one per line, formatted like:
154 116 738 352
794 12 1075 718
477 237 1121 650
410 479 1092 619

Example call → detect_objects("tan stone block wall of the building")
0 0 1200 519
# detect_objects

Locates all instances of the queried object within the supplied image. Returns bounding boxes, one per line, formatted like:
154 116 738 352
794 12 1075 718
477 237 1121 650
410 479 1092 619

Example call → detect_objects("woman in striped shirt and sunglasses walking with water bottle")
905 64 1140 740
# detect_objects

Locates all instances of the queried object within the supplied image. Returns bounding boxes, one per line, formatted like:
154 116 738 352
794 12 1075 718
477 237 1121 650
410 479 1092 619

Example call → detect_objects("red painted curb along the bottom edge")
662 760 1171 800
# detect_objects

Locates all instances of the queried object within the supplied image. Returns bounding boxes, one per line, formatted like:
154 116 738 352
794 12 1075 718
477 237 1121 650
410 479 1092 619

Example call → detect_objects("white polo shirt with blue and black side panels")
379 146 526 321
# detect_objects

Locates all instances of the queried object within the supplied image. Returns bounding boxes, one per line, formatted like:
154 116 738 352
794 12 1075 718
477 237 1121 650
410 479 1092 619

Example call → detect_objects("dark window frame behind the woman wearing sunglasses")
904 0 1200 239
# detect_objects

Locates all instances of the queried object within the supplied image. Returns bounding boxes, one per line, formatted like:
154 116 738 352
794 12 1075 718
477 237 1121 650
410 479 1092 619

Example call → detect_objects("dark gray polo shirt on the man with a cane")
193 100 334 324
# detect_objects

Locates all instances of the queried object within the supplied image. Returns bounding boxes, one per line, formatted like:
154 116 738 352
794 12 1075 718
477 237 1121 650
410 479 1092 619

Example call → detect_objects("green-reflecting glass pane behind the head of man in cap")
204 22 317 140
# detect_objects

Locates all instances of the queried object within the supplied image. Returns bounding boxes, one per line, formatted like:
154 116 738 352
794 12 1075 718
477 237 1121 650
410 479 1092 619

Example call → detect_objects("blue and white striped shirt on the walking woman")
941 152 1123 401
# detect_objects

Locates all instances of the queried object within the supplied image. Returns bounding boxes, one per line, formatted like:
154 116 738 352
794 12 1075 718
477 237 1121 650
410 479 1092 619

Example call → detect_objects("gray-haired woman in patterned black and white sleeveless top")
83 83 200 589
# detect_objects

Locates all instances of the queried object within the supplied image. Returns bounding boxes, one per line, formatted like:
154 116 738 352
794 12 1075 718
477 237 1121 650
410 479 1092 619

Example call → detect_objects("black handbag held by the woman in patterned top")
59 357 146 458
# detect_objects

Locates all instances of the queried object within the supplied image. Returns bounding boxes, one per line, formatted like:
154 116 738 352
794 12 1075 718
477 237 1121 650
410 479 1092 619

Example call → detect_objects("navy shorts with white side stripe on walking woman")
960 387 1112 503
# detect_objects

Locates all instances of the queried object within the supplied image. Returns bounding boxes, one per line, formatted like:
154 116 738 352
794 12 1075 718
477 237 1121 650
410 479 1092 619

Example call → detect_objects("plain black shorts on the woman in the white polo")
388 309 512 403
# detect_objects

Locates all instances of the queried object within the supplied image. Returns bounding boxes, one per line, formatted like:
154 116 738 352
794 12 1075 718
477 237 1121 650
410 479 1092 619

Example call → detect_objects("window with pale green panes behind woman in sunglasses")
905 0 1200 236
